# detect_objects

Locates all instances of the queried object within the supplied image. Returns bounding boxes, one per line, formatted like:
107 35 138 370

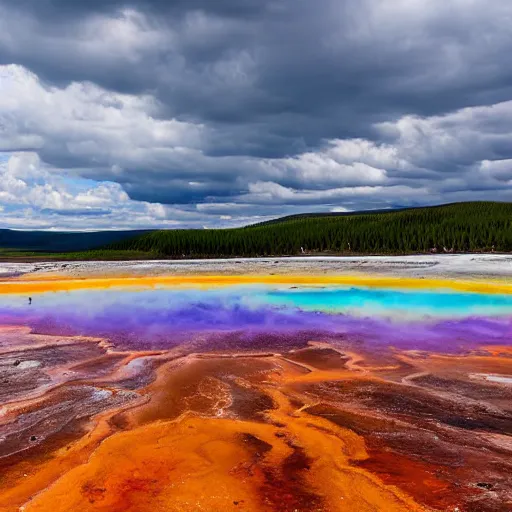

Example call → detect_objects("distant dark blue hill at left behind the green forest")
0 229 147 253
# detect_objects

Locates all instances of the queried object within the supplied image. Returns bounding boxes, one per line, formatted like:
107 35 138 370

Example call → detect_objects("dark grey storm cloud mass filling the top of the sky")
6 0 512 151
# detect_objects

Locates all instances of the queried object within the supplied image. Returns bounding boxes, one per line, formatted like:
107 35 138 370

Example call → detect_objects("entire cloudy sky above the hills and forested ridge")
0 0 512 230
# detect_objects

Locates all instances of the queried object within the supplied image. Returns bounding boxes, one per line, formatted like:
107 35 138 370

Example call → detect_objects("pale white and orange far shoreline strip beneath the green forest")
0 254 512 286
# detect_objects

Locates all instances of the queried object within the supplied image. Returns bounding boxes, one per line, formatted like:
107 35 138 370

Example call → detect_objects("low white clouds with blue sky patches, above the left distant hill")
0 153 192 230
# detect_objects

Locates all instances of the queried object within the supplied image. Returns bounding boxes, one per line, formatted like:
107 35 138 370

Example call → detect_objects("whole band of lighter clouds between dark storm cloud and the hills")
0 58 512 229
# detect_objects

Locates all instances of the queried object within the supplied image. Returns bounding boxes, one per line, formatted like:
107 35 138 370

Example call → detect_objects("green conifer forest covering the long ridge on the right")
108 202 512 258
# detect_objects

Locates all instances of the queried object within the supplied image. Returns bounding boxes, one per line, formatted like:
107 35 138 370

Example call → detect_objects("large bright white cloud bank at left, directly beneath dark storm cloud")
0 65 203 170
